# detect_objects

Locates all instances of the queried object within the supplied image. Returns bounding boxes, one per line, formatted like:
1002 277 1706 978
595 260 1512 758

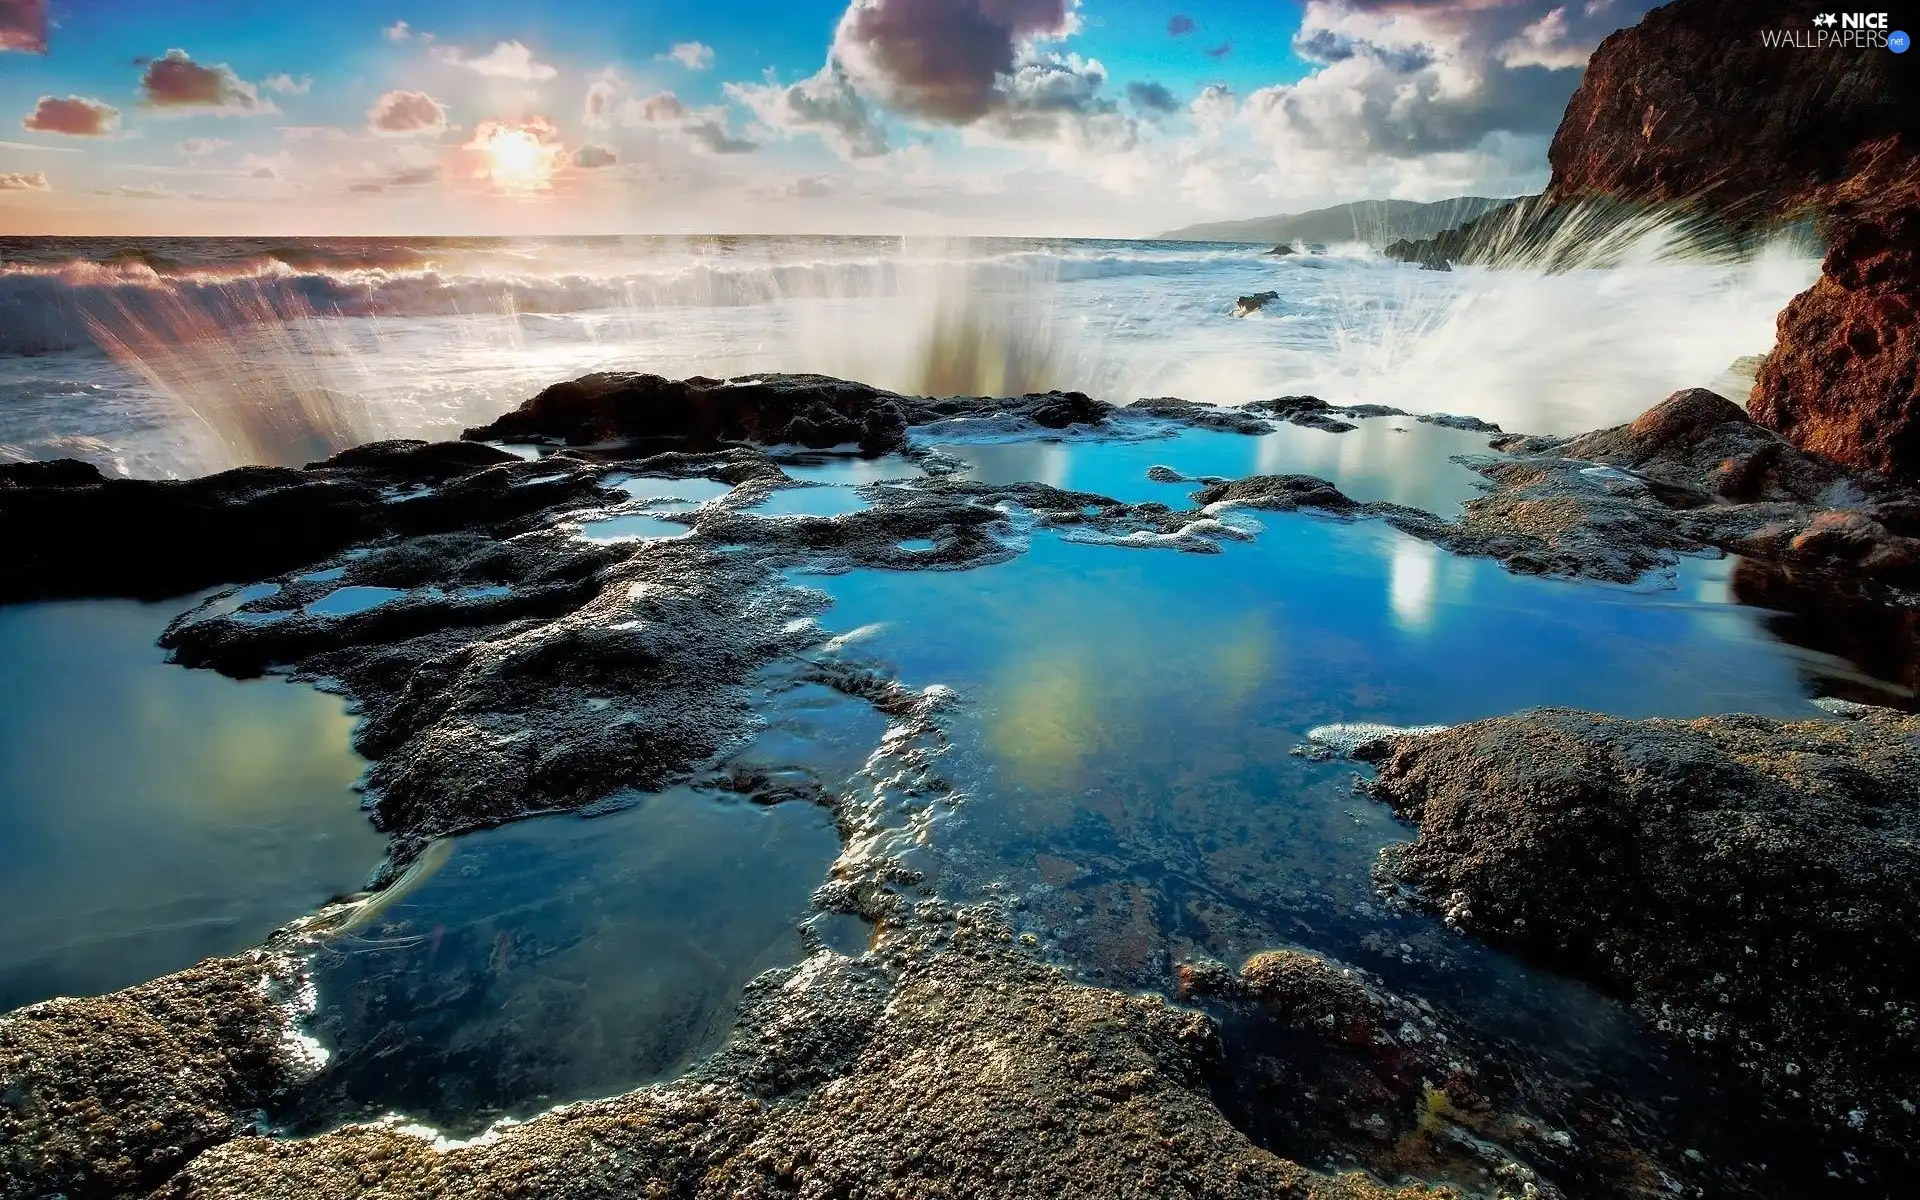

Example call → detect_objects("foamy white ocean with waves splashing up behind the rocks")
0 230 1816 476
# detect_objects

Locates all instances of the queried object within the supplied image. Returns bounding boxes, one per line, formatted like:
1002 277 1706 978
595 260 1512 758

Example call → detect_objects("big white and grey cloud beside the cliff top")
1244 0 1649 159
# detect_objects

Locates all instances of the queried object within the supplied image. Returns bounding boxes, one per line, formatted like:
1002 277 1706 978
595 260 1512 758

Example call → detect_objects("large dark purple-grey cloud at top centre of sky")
833 0 1079 125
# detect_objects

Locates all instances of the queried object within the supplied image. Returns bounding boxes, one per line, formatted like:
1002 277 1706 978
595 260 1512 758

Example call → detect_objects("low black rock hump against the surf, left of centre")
465 372 910 451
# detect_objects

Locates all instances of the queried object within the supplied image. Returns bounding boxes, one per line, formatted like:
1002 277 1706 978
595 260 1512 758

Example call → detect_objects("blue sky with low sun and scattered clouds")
0 0 1651 236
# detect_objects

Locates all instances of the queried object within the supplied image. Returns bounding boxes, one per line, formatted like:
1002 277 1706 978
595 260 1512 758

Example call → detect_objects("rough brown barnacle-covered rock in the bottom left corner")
0 954 303 1200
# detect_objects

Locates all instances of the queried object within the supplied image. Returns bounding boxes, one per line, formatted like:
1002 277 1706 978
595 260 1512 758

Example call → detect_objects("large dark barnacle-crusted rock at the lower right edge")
1373 708 1920 1154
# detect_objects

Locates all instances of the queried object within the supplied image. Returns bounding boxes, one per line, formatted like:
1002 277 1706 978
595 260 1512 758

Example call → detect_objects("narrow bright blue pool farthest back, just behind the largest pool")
931 417 1488 516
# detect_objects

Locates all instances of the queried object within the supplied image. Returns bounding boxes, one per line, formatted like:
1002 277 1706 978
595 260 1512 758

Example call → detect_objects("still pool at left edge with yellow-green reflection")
0 591 386 1012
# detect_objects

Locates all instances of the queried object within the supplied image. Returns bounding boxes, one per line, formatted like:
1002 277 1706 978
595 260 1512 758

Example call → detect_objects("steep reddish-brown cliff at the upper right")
1548 0 1920 478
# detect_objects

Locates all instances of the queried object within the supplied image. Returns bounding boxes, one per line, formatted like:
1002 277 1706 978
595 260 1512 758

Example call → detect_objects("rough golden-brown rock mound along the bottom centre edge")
159 940 1450 1200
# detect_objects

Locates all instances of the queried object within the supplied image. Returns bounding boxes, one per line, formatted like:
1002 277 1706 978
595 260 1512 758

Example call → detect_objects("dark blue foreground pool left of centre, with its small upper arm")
282 685 885 1133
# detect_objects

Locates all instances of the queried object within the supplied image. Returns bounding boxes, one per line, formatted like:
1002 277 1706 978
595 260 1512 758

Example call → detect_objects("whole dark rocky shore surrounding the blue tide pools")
0 360 1920 1200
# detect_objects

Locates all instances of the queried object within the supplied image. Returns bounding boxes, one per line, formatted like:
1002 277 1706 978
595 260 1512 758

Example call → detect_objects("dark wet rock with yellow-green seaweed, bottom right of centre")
1183 947 1704 1200
